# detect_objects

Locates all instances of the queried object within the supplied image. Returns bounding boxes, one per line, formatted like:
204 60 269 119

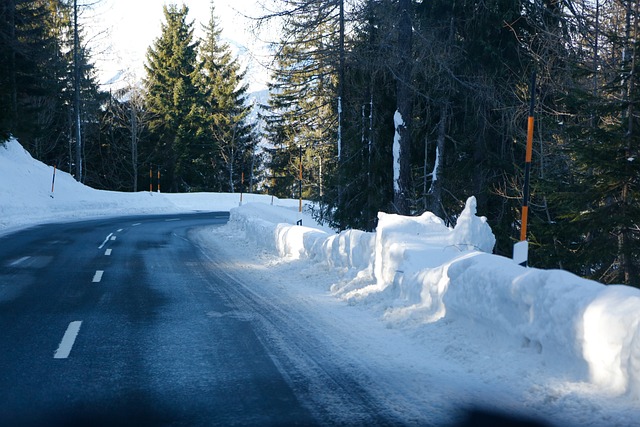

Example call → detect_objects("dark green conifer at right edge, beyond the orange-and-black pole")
552 2 640 287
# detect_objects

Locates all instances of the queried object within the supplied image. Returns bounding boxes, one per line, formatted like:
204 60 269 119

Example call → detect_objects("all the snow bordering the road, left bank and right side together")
0 141 640 426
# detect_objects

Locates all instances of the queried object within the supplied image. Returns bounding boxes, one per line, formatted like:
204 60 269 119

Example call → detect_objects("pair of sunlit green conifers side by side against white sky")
145 5 255 192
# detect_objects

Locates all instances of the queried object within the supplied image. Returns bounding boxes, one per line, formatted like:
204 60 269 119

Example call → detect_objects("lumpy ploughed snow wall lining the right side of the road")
230 198 640 399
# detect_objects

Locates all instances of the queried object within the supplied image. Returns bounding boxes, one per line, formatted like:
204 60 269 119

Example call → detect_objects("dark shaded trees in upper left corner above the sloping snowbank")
0 0 104 175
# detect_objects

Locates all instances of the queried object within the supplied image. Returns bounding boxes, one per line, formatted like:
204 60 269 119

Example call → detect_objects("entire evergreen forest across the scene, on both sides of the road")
0 0 640 287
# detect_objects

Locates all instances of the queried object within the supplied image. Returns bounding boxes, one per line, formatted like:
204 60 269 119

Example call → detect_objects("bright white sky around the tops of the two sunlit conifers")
90 0 273 92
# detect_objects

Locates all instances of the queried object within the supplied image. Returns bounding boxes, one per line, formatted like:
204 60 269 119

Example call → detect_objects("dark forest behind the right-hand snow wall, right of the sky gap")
266 0 640 286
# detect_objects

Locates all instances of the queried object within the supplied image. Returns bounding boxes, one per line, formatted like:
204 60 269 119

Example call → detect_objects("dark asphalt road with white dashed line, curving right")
0 212 398 426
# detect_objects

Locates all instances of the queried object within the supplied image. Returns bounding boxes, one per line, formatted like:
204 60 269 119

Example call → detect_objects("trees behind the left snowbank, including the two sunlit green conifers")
0 0 261 191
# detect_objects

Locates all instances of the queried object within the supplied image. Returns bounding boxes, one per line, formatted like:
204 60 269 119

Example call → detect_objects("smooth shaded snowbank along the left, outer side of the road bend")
0 139 290 233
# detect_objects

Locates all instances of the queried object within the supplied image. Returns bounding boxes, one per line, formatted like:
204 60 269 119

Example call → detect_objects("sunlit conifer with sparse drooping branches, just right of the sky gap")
262 0 344 204
